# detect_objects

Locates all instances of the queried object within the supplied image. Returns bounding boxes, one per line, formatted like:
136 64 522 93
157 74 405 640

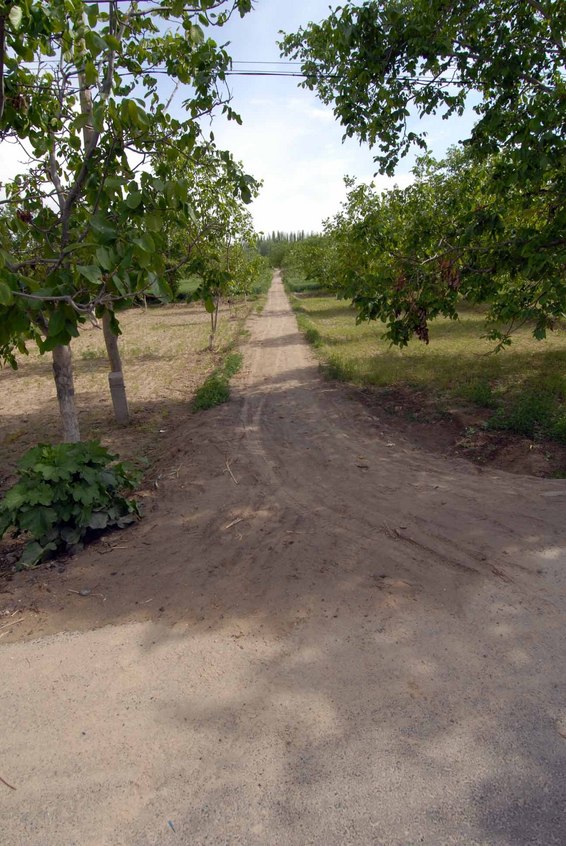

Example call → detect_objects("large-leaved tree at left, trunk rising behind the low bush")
0 0 251 441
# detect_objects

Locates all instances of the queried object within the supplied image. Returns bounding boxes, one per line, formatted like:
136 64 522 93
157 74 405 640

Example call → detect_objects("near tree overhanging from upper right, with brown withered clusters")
281 0 566 343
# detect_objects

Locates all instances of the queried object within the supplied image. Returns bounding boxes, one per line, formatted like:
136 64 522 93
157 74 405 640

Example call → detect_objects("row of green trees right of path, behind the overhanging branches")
287 142 566 346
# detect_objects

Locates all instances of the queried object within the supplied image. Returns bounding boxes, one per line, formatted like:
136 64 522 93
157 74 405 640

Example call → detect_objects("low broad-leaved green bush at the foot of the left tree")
0 441 140 568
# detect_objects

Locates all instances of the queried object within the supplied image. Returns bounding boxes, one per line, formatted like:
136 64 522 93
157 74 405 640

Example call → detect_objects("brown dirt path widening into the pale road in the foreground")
0 279 566 846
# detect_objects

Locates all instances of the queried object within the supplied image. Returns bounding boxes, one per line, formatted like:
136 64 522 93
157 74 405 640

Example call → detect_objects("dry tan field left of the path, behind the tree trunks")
0 304 253 487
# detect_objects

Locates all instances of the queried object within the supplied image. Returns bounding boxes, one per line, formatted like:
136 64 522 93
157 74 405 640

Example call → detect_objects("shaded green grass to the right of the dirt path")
291 288 566 443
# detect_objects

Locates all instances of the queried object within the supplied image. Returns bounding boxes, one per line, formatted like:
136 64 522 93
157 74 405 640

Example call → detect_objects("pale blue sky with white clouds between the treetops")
0 0 480 233
